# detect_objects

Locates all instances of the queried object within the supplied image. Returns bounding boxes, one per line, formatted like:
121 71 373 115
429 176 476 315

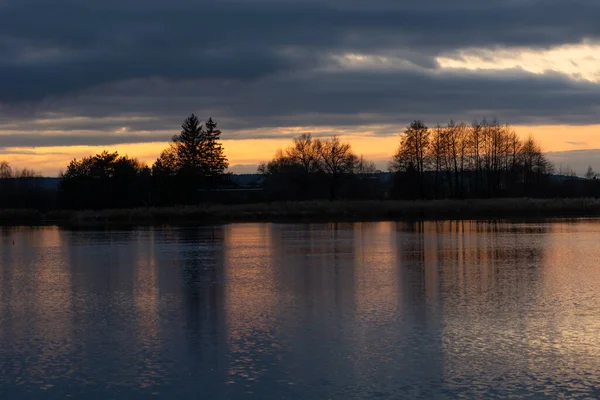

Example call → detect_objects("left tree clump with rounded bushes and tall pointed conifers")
58 114 229 208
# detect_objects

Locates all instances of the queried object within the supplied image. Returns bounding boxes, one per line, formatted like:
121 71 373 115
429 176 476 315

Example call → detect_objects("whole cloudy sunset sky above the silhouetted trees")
0 0 600 176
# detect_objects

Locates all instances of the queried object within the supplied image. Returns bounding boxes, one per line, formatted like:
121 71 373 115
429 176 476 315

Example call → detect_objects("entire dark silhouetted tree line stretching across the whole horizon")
0 114 600 209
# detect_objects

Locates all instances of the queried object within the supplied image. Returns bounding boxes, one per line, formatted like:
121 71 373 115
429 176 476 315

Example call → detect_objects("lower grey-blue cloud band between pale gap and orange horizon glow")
0 70 600 144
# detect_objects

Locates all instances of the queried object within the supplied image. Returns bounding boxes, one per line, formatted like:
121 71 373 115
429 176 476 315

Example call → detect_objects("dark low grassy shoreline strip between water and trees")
0 198 600 228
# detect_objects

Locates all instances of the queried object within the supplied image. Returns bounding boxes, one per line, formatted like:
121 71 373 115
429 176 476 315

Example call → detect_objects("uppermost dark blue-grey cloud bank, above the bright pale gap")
0 0 600 96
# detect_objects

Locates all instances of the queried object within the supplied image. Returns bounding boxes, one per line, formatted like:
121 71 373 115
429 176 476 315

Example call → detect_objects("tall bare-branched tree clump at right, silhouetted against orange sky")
390 119 554 198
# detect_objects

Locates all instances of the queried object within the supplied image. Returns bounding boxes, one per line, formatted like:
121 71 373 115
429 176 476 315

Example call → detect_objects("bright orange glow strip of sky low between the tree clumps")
0 125 600 176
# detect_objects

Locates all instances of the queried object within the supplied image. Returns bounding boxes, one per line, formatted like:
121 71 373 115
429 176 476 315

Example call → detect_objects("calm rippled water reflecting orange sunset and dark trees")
0 220 600 399
